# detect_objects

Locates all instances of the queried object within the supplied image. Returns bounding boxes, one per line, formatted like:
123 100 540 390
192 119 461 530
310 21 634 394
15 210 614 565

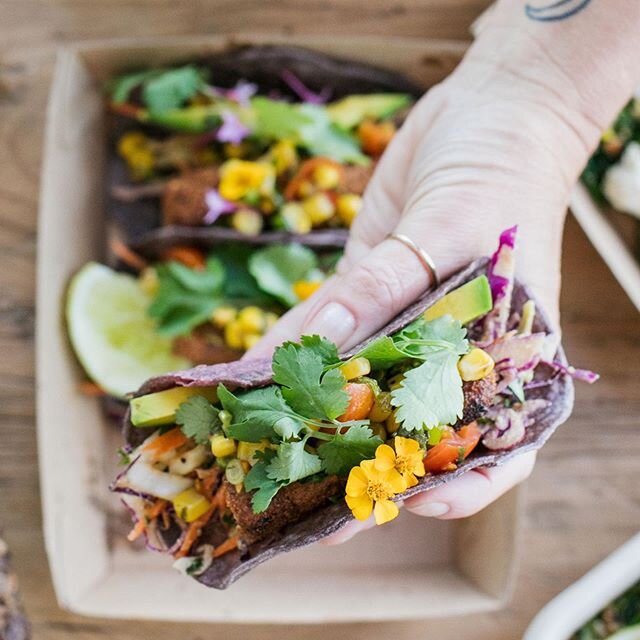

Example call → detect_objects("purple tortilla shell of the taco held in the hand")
124 259 574 589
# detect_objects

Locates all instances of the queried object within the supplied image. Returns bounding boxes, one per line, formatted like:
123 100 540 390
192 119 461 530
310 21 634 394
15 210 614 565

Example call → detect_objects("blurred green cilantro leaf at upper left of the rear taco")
142 65 204 114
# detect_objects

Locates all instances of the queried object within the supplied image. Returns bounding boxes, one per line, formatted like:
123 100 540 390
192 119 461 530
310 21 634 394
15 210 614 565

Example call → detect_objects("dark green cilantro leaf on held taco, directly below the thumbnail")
273 342 349 420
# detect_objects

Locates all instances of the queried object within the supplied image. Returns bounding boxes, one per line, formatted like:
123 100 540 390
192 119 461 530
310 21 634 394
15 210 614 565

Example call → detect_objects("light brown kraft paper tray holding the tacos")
37 35 519 623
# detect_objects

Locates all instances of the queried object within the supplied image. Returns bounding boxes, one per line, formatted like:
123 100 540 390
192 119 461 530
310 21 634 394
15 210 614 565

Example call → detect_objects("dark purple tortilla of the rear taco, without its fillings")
106 45 424 256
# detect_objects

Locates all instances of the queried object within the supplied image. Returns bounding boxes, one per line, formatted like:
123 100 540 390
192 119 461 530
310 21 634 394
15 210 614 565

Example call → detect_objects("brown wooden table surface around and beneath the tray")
0 0 640 640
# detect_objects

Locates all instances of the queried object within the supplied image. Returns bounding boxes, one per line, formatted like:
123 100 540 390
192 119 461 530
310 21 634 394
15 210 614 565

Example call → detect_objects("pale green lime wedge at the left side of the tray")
66 262 190 398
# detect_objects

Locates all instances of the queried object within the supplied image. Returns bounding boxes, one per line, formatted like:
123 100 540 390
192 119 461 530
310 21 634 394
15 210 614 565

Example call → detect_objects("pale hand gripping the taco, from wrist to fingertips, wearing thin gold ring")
245 53 586 542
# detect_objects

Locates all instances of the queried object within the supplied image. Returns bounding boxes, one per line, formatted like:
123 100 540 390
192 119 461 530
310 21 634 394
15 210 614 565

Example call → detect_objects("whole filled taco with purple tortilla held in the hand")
112 229 596 588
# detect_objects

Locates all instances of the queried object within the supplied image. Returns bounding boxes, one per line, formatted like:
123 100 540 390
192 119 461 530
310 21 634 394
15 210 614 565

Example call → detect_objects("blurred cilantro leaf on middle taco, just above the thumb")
249 243 319 307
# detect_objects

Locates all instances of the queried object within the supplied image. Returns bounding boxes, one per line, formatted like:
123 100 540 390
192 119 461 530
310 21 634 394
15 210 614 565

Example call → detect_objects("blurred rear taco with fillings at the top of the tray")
107 46 422 252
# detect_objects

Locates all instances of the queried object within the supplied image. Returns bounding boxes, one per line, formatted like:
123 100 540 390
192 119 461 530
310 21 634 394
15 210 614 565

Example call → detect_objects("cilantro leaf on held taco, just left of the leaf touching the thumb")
218 384 304 442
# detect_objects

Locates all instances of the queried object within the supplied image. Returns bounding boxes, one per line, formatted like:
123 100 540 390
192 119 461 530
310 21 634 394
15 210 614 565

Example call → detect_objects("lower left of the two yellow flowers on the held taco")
345 460 405 524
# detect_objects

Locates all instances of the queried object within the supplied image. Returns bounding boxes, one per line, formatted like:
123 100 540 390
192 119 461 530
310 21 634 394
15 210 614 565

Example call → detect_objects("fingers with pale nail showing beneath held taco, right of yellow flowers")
404 452 536 520
